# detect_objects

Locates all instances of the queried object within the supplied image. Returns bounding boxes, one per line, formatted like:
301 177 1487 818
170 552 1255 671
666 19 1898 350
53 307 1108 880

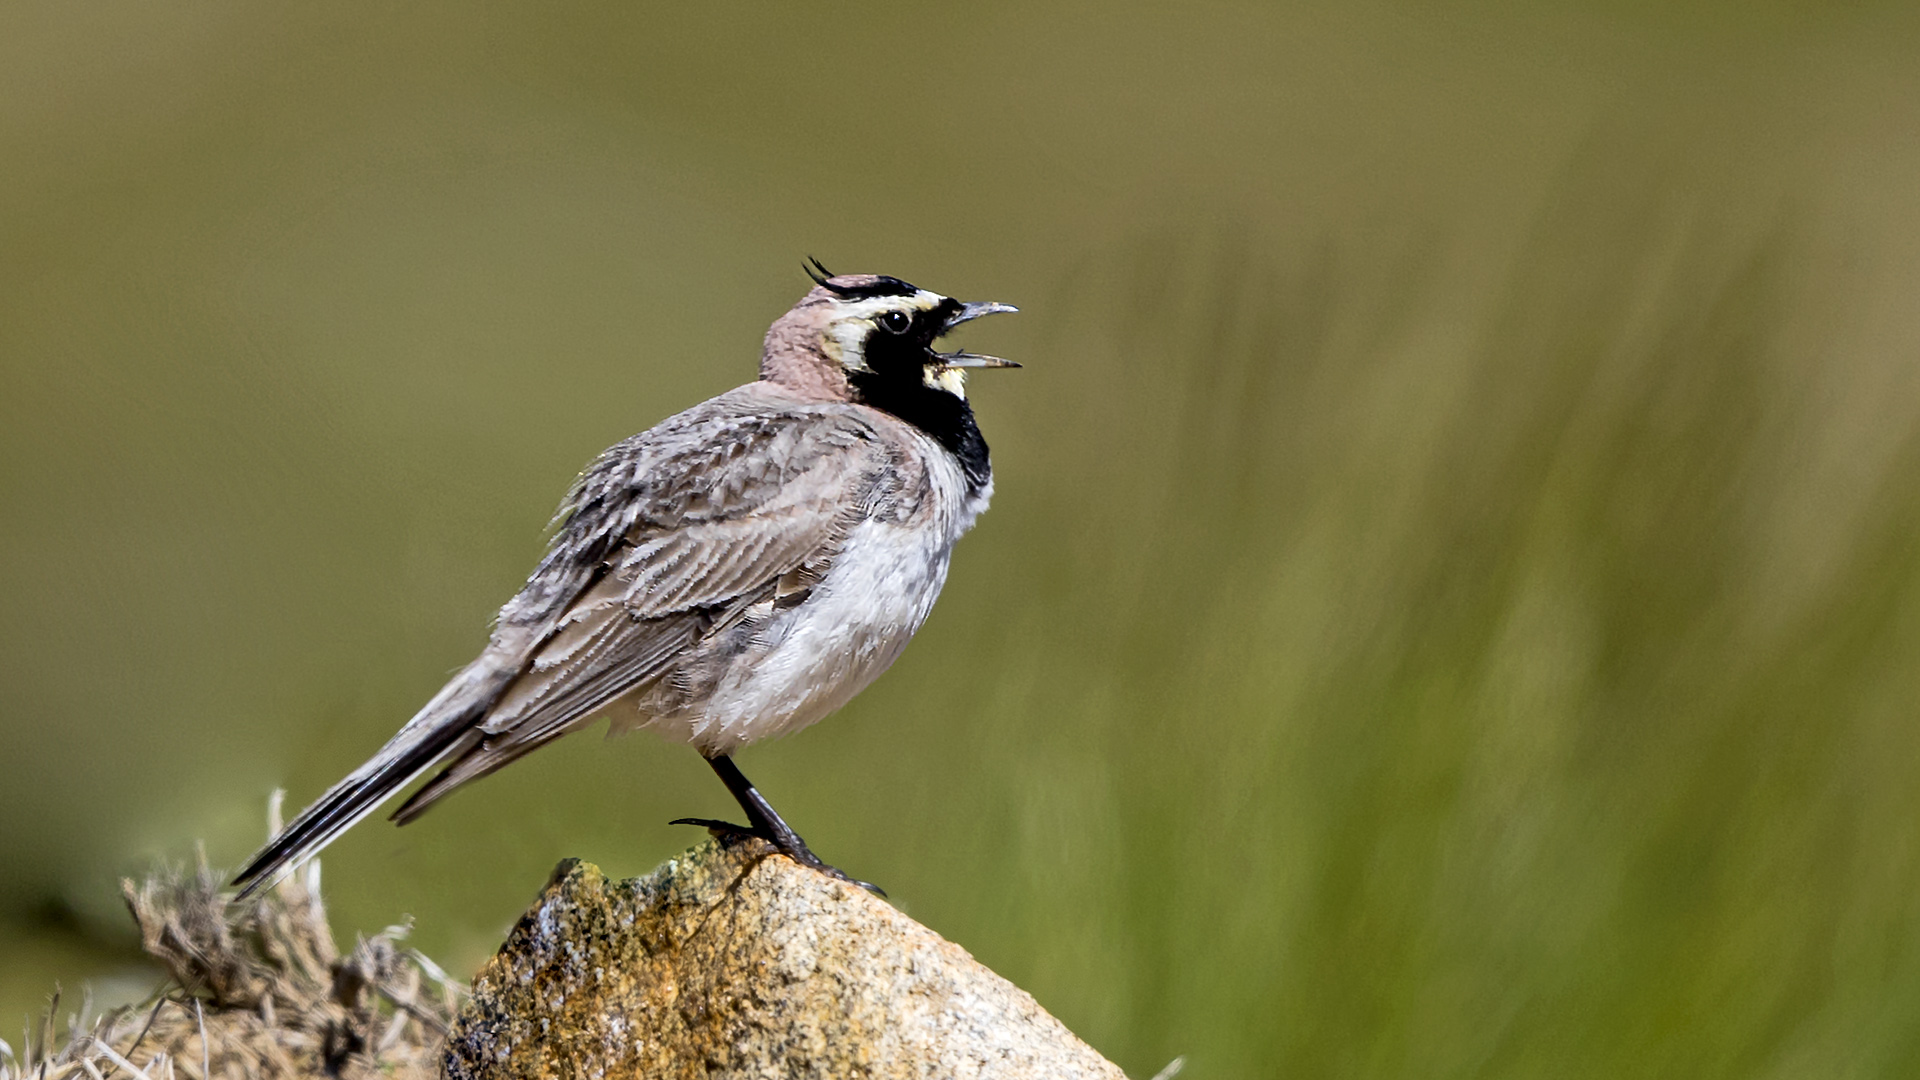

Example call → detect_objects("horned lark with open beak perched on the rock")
232 259 1020 899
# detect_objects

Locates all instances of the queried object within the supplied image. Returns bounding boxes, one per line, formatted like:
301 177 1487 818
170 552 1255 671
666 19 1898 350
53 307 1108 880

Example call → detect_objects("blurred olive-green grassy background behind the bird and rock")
0 0 1920 1078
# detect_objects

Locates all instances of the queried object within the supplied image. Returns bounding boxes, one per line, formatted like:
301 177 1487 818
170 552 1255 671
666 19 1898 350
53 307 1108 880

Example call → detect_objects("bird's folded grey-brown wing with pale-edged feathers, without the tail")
394 411 887 810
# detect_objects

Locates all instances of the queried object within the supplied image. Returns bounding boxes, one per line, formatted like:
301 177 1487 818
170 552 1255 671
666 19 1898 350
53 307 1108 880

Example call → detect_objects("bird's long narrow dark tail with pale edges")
232 655 515 899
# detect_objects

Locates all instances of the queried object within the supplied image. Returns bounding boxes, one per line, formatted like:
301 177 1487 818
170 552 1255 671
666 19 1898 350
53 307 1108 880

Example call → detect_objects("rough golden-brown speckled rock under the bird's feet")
445 838 1123 1080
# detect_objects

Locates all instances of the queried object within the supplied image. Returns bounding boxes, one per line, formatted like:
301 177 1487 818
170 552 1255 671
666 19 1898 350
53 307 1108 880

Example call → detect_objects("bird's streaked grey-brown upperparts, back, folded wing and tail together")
236 393 891 896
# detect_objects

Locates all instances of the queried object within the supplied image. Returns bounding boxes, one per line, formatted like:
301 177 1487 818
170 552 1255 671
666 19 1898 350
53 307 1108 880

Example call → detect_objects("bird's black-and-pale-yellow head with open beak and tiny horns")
760 261 1020 407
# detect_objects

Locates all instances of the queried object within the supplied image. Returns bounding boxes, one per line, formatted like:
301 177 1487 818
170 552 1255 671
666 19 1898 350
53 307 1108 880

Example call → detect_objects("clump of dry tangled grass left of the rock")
0 803 465 1080
